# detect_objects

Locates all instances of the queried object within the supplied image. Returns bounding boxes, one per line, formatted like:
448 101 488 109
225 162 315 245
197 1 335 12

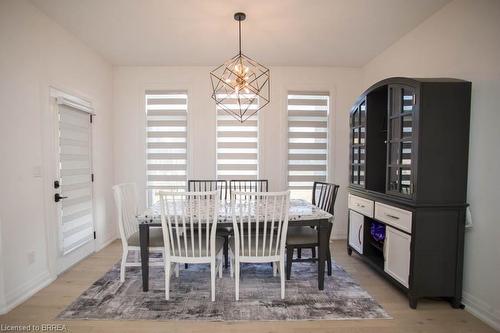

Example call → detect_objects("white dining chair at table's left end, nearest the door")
113 183 163 282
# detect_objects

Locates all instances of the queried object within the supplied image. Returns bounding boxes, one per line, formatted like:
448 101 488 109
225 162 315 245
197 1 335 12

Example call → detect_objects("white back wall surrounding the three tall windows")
113 66 361 238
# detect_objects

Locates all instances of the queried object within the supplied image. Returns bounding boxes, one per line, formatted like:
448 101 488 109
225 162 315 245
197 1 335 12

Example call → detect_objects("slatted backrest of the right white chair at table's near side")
231 191 290 257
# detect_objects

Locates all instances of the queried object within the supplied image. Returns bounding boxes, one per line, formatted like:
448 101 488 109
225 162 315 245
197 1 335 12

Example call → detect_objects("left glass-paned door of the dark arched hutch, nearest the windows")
350 100 366 187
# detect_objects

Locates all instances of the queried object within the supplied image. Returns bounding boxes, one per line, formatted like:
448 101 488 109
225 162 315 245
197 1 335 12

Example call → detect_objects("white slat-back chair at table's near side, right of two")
229 191 290 300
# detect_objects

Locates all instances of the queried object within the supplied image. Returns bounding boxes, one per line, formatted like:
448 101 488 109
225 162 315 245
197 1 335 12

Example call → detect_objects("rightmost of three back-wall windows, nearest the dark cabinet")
288 92 330 201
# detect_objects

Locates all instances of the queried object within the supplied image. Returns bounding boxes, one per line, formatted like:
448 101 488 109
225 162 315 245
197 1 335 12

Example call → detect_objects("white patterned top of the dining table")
137 199 333 223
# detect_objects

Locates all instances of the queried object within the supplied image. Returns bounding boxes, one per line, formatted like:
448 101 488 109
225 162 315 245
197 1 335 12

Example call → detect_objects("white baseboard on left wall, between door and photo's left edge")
0 271 56 314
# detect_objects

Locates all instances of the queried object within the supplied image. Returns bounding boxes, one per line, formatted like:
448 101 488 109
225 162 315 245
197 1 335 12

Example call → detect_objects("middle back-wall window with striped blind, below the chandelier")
217 94 259 180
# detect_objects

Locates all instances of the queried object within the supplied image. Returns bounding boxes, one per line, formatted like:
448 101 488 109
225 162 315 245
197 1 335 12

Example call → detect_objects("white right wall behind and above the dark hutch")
364 0 500 329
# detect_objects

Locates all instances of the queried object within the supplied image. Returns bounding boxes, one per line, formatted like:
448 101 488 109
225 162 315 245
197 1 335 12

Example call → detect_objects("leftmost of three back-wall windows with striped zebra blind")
146 90 187 204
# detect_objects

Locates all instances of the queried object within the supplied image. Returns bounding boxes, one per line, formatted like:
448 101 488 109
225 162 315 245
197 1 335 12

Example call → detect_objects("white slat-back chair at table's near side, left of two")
159 191 224 302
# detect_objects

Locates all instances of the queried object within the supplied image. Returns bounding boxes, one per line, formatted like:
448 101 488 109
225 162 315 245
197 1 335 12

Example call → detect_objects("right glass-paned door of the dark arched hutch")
387 85 417 197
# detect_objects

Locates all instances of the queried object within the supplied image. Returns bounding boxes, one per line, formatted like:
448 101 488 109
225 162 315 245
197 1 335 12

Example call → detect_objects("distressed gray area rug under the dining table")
58 252 390 321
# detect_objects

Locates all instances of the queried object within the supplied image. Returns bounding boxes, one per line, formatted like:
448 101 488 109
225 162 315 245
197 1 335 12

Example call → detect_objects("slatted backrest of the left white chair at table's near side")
159 190 219 258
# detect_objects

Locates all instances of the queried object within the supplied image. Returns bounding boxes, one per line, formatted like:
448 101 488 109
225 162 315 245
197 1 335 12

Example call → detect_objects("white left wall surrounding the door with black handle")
0 0 116 312
